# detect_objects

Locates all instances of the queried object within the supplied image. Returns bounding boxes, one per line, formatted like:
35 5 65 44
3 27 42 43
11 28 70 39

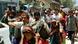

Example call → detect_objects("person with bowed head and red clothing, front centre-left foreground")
20 26 35 44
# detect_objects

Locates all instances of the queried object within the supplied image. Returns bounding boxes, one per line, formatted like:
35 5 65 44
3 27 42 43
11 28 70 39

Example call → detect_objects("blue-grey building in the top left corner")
0 0 19 19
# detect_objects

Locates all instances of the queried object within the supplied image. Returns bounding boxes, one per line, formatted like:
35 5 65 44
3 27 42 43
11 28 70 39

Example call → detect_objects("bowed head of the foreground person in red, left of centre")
23 26 34 40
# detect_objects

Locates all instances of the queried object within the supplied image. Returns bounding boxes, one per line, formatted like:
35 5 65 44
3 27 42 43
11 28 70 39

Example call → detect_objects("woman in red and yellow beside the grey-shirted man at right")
60 11 67 44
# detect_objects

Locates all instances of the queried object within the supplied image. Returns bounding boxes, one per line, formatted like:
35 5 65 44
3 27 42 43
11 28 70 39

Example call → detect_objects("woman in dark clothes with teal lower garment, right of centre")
50 20 60 44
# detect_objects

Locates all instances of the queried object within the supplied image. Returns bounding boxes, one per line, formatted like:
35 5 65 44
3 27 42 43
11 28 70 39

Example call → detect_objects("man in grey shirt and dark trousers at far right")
67 10 77 44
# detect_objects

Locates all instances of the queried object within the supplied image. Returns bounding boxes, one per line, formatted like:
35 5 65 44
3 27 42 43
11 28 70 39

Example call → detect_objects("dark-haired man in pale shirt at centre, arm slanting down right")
31 12 49 32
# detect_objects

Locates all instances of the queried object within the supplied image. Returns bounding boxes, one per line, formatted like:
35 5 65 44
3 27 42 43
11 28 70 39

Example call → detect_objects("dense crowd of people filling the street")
1 7 78 44
